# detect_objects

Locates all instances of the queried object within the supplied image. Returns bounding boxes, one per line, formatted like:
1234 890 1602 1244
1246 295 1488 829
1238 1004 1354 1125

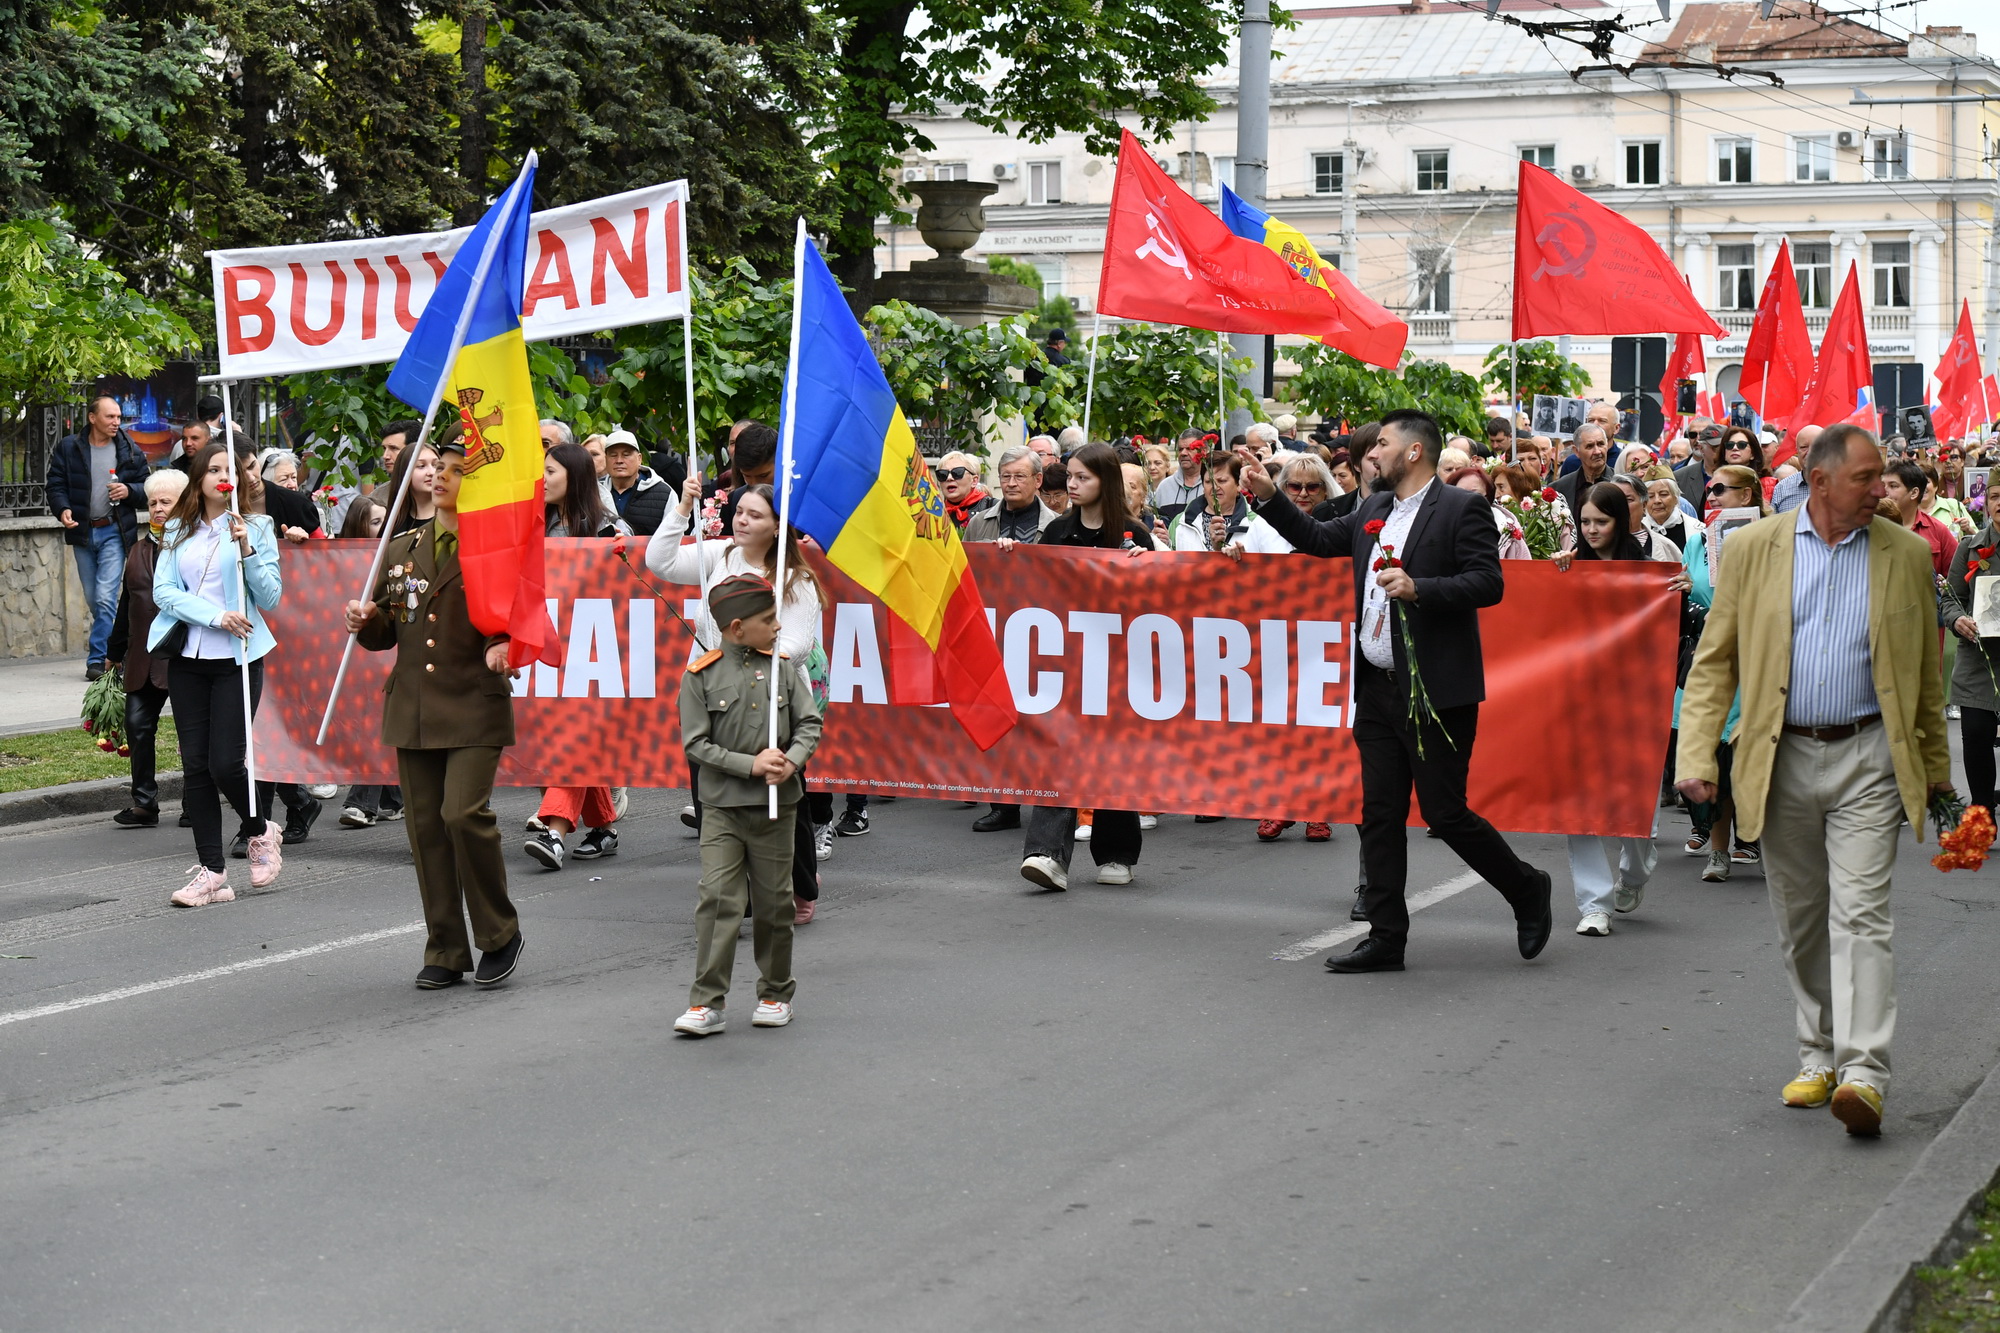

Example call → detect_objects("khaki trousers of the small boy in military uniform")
688 801 798 1009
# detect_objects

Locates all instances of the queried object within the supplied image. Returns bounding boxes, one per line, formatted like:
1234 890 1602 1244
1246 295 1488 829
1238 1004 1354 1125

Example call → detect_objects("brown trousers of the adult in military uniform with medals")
396 745 520 973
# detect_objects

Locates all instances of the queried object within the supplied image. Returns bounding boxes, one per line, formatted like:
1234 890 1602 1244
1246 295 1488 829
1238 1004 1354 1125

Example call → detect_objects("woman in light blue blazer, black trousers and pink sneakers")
146 444 284 907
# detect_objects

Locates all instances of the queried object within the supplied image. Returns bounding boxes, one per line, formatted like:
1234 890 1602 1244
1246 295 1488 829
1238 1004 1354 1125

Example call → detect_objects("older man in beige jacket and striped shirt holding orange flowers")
1676 426 1952 1135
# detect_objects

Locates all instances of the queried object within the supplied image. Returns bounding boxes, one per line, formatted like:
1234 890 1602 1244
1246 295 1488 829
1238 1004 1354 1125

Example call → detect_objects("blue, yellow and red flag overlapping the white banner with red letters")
388 152 562 667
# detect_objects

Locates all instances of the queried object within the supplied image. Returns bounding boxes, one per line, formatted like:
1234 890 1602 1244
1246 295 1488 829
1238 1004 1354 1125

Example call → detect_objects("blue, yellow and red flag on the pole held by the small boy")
782 224 1018 751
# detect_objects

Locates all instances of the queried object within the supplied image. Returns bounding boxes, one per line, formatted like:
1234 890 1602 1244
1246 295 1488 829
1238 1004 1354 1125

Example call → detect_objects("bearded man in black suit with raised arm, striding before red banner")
1238 410 1554 973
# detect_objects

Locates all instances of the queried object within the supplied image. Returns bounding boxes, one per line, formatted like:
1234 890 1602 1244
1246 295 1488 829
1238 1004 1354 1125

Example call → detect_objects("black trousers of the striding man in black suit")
1354 660 1540 951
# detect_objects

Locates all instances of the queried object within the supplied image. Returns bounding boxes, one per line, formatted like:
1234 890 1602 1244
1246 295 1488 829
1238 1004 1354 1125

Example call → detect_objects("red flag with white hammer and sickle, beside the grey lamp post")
1098 130 1342 338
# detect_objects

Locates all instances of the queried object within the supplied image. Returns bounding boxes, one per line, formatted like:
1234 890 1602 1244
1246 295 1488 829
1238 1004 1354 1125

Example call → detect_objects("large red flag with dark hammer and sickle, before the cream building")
1514 162 1722 342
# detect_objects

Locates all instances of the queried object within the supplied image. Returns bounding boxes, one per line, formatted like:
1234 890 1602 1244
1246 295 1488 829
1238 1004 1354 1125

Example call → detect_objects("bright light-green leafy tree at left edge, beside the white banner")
0 218 194 402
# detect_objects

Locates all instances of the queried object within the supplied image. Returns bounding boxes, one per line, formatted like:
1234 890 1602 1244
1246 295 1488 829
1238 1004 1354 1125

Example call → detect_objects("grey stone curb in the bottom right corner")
1778 1067 2000 1333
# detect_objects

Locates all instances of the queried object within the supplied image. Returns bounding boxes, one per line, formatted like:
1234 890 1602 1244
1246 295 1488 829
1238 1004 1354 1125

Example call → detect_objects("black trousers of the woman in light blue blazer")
166 656 264 873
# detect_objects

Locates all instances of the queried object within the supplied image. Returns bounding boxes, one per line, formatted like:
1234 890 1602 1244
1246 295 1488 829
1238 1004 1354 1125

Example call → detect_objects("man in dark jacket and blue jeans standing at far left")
46 394 146 681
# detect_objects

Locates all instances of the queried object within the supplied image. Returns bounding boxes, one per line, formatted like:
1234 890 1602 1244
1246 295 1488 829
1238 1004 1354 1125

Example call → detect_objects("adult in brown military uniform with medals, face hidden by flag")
348 436 522 991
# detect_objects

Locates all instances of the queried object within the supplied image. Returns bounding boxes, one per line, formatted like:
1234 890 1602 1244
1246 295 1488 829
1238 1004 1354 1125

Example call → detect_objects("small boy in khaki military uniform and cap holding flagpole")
674 574 820 1037
